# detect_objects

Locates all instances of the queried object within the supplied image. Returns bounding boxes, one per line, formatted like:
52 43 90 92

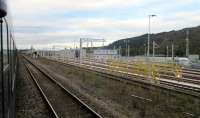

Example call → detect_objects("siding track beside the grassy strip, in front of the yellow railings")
52 57 200 97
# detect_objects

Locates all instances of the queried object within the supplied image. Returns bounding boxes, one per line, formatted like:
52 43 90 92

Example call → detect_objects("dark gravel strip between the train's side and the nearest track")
16 58 52 118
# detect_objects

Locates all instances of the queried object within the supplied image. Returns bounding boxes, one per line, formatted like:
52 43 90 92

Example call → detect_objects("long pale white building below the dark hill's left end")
93 49 120 61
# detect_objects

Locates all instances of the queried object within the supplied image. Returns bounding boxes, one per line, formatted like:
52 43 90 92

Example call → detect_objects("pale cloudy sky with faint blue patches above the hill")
9 0 200 48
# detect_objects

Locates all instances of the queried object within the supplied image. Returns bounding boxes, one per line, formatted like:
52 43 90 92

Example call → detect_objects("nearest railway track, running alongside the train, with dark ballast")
24 57 102 118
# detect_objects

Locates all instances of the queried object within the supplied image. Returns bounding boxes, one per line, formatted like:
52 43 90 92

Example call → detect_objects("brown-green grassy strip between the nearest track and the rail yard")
28 56 200 118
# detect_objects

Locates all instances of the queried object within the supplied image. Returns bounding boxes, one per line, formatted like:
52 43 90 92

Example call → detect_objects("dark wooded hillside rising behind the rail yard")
106 26 200 56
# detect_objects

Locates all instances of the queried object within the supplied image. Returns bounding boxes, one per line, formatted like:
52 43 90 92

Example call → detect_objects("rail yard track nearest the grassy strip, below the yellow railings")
46 57 200 97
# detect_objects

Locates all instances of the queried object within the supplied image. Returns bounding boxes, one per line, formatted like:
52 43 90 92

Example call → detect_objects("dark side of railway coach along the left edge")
0 0 17 118
